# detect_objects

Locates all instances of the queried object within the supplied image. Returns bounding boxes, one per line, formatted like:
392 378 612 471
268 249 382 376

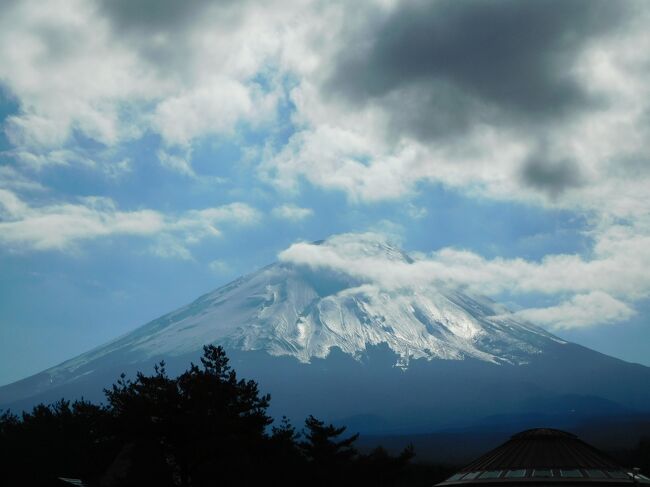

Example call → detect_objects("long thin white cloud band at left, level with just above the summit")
0 190 259 258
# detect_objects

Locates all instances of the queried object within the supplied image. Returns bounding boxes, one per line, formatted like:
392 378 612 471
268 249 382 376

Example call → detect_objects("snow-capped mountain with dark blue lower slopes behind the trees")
0 237 650 432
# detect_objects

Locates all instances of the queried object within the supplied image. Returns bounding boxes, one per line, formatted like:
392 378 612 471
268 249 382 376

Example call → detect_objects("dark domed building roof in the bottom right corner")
438 428 650 487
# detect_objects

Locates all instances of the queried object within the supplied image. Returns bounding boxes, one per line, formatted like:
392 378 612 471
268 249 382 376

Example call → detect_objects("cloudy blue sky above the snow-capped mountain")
0 0 650 384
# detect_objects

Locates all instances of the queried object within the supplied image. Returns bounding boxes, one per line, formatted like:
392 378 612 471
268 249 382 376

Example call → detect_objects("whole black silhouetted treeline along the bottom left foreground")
0 346 447 487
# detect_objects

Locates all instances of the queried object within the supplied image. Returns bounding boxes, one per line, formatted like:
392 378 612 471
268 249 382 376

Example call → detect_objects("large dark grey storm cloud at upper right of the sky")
325 0 631 139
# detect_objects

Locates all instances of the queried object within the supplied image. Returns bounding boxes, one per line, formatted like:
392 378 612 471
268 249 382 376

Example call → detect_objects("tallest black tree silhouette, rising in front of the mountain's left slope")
105 345 272 486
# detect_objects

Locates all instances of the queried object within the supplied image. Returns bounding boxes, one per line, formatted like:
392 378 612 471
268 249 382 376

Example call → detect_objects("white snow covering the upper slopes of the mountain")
48 234 563 376
